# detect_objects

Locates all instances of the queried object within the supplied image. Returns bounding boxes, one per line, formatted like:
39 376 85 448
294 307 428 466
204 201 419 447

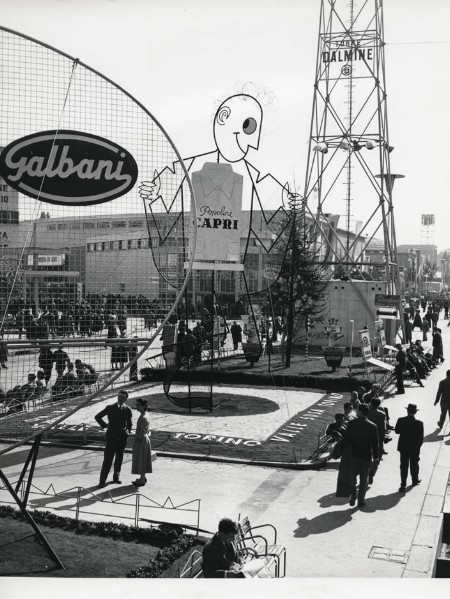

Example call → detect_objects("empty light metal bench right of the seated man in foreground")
238 516 286 578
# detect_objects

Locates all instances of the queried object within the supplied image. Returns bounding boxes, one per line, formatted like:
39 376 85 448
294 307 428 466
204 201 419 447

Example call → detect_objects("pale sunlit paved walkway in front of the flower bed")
0 327 450 597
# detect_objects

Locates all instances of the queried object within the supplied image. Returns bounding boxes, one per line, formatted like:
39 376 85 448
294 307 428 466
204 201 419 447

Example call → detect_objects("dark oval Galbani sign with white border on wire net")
0 130 138 206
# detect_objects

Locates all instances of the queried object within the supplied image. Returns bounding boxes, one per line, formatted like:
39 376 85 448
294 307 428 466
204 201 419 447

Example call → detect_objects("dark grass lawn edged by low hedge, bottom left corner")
0 517 192 578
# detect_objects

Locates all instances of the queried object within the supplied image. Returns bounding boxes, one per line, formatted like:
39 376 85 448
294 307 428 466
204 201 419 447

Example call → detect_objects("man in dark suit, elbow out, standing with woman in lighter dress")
95 390 132 488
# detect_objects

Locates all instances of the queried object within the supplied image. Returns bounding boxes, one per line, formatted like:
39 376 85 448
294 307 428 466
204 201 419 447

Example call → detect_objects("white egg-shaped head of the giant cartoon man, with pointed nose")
214 94 262 162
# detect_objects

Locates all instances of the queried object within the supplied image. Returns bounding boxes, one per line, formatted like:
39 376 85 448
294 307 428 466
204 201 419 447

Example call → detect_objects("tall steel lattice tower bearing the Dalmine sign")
304 0 398 293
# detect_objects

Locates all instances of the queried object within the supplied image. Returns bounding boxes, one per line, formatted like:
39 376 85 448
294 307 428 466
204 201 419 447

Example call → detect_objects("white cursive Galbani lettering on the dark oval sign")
5 144 131 183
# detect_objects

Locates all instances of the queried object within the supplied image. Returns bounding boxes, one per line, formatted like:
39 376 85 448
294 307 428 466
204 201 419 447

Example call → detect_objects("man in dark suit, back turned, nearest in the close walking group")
344 403 379 507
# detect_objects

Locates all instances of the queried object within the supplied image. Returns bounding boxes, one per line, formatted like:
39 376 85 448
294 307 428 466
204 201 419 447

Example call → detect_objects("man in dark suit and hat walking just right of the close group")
395 403 423 493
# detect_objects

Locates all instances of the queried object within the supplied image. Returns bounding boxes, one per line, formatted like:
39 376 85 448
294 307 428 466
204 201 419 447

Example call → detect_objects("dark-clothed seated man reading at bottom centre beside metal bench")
202 518 244 578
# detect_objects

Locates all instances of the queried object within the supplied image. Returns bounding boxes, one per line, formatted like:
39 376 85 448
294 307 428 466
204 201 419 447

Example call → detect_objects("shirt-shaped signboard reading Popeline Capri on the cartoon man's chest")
192 162 244 263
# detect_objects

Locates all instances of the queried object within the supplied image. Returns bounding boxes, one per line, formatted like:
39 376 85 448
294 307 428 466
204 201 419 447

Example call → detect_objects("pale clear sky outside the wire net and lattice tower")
0 0 450 250
